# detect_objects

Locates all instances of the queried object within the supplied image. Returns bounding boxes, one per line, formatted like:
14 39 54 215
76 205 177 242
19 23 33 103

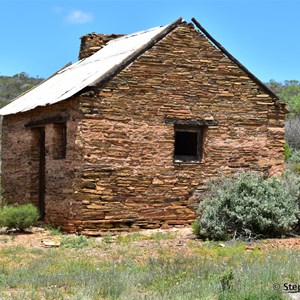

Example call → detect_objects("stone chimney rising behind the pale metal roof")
78 32 124 59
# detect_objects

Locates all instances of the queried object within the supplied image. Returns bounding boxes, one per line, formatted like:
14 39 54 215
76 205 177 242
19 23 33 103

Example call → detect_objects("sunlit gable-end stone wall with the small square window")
78 25 284 234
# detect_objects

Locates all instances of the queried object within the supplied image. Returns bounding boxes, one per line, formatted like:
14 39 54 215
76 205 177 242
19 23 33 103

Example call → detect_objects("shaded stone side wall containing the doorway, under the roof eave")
2 100 81 231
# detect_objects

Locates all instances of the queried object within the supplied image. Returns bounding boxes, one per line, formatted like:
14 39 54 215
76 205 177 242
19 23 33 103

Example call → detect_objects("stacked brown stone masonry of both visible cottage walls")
2 24 284 235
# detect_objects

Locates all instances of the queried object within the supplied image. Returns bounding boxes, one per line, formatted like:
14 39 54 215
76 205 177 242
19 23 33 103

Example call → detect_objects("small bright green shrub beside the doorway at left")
0 204 39 231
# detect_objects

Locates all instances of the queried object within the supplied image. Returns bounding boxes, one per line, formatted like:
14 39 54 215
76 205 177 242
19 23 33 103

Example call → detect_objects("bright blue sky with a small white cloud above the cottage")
0 0 300 82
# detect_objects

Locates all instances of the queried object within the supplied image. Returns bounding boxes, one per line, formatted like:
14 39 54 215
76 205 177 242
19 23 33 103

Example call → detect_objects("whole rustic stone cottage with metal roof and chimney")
0 18 285 235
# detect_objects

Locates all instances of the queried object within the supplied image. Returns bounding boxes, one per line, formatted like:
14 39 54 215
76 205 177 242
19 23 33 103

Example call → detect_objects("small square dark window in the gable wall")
174 126 203 161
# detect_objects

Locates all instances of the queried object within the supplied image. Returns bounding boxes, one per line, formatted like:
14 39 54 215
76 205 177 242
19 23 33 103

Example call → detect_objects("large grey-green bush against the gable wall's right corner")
193 172 299 240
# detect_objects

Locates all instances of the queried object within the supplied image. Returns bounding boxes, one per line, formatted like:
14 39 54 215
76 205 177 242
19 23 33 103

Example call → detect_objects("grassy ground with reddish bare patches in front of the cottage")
0 229 300 300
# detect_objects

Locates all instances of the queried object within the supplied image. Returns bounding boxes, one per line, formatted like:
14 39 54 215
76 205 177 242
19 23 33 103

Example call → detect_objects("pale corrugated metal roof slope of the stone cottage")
0 19 181 115
